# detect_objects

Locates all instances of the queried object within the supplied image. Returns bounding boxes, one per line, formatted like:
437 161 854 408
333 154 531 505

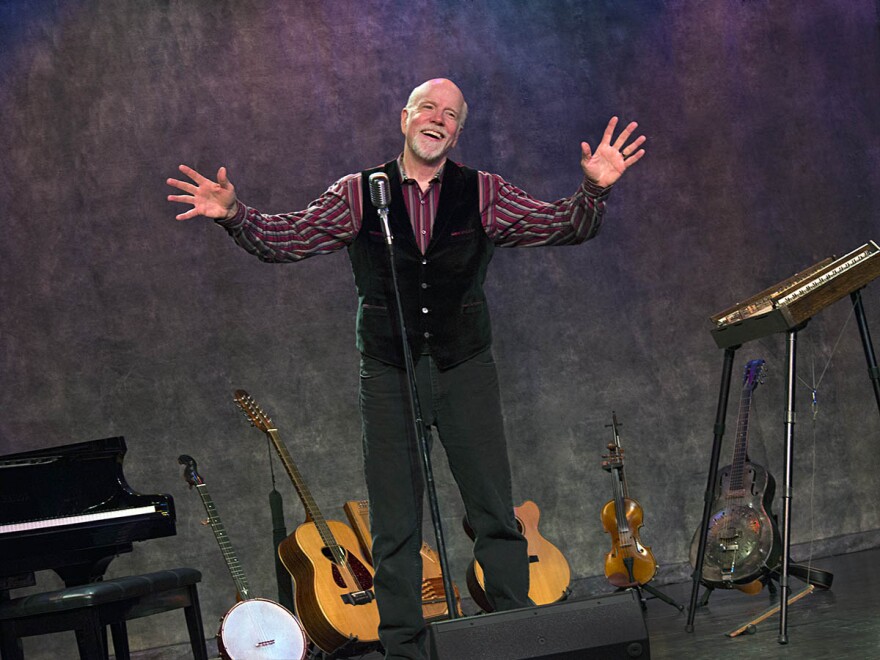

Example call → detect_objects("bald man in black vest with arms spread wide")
168 79 645 660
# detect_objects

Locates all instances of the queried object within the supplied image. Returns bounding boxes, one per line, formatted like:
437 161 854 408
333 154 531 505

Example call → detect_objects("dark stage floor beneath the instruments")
132 548 880 660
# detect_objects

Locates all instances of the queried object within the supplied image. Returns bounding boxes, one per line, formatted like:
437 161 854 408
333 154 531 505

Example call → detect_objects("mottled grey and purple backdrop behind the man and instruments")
0 0 880 658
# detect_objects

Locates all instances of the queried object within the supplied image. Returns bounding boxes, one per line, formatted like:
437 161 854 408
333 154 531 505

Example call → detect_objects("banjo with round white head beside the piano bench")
177 454 308 660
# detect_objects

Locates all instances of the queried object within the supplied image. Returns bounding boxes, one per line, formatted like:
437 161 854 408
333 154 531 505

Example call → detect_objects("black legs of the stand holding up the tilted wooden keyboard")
685 289 880 644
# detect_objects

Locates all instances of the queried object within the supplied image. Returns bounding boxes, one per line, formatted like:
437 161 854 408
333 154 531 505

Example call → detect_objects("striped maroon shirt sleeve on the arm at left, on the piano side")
217 173 362 262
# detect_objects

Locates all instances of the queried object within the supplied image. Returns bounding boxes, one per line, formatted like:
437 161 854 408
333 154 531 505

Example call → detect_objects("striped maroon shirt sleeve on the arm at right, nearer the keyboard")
479 172 610 247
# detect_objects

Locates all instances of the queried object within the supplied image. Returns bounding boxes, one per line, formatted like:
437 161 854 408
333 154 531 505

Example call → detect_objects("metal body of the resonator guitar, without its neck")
690 461 782 588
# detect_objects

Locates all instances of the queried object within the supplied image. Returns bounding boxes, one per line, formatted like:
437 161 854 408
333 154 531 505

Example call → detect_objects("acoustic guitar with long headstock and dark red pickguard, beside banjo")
235 390 379 654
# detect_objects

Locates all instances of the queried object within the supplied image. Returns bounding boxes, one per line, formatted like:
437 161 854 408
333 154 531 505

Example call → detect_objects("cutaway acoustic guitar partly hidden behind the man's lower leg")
463 500 571 612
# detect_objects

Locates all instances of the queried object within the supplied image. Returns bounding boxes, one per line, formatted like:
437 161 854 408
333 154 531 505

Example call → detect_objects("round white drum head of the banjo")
217 598 308 660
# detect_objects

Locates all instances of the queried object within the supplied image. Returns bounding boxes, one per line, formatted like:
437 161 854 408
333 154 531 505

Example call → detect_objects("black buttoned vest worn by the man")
348 160 495 369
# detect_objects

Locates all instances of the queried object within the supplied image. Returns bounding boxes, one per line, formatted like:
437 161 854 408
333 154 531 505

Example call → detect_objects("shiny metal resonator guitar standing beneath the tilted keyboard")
690 360 782 594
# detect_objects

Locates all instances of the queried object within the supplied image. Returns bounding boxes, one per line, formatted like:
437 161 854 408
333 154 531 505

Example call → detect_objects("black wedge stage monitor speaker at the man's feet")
428 591 651 660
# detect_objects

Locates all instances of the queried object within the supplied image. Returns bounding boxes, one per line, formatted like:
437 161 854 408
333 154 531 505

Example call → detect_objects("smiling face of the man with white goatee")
400 80 464 164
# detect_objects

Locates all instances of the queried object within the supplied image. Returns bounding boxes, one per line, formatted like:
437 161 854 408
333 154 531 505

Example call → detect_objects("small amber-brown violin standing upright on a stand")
601 411 657 589
